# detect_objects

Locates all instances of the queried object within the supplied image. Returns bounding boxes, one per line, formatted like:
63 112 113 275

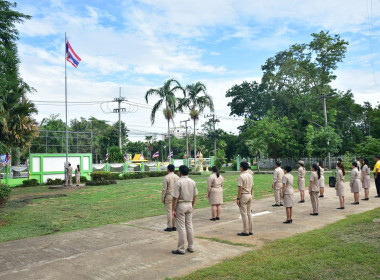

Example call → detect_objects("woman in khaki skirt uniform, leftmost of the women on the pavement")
206 166 224 221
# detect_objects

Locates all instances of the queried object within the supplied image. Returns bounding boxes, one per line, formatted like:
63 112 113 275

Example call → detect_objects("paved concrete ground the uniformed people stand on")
0 182 380 280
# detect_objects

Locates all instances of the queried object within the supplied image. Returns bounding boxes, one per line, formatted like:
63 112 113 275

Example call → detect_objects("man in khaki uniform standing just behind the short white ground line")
236 162 253 236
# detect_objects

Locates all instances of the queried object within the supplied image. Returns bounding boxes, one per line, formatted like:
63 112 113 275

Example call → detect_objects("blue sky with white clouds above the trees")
17 0 380 140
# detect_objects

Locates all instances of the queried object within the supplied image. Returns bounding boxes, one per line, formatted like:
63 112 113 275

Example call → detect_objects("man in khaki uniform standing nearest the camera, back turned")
172 165 198 255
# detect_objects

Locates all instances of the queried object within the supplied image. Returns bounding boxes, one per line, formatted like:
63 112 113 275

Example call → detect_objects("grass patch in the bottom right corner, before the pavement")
176 208 380 280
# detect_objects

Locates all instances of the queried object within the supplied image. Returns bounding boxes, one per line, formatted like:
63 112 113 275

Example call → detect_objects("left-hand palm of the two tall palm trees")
145 79 185 154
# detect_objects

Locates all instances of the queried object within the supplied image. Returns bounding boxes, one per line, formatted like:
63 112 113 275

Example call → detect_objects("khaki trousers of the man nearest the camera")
176 202 194 253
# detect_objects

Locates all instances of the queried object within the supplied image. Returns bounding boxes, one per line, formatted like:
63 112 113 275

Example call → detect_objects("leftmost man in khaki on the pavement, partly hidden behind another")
161 164 179 232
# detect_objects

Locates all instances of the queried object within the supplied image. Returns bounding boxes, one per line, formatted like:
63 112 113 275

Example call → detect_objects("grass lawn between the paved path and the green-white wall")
0 172 328 242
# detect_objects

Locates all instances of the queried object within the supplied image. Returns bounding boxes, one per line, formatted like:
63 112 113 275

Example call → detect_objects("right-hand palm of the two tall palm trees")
179 82 214 171
